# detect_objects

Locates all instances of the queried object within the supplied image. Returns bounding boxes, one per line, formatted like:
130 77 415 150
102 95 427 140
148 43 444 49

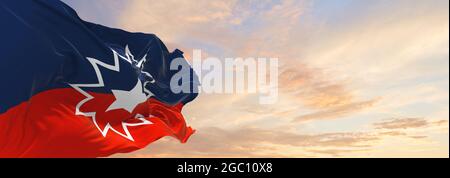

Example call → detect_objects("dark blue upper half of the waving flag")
0 0 198 113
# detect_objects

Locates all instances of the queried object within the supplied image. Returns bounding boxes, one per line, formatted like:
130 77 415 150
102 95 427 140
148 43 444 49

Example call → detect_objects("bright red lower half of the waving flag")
0 89 194 157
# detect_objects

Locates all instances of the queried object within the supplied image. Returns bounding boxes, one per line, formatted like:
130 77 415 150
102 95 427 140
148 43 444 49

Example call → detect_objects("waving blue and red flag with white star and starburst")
0 0 197 157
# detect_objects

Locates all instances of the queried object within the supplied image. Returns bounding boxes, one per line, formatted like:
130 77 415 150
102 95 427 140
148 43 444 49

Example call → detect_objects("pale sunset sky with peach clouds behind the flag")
63 0 449 158
